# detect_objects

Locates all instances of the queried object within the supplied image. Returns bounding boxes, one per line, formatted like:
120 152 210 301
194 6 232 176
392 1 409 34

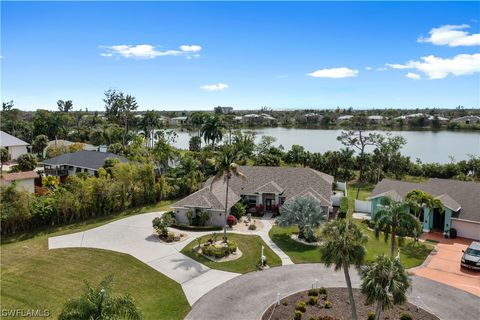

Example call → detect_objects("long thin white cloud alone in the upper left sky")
100 44 202 59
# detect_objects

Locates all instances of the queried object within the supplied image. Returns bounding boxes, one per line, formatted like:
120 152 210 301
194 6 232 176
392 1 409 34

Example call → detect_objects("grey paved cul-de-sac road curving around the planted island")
186 264 480 320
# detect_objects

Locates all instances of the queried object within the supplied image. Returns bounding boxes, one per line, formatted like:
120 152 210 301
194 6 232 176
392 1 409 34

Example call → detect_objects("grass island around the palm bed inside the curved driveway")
181 233 282 273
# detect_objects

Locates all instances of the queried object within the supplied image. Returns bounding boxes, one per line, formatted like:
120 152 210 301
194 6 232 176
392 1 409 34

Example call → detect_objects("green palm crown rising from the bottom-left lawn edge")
58 276 142 320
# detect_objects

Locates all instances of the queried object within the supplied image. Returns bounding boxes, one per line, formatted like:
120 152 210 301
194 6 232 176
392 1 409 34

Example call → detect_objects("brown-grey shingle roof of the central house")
172 166 334 210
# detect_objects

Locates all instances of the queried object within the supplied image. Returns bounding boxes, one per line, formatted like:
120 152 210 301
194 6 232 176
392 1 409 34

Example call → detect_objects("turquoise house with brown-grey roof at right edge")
369 179 480 240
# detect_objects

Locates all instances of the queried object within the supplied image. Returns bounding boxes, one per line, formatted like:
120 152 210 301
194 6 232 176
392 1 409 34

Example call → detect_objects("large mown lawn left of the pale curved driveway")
0 199 190 319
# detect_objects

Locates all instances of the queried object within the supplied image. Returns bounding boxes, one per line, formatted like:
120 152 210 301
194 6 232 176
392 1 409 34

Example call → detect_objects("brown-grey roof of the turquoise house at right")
370 179 480 222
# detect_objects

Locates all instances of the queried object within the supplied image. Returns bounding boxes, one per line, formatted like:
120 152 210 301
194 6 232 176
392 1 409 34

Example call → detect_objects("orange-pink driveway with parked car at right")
409 235 480 296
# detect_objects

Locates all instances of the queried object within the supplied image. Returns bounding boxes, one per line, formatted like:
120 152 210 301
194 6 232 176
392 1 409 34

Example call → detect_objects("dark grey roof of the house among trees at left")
43 150 128 170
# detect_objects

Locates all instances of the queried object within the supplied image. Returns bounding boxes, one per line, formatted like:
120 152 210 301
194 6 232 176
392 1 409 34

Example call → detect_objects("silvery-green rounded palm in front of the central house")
277 197 326 242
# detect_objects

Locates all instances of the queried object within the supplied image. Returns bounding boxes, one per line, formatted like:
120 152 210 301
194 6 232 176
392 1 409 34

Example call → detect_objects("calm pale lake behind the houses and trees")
171 127 480 163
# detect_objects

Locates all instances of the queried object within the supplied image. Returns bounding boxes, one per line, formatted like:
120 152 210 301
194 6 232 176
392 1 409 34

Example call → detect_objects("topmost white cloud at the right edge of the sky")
417 24 480 47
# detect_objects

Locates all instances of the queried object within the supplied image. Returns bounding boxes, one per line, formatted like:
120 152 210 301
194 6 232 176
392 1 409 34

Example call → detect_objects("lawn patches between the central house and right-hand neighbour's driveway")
269 222 433 268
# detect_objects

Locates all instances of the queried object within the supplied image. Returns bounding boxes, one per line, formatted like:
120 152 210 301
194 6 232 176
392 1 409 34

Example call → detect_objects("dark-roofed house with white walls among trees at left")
43 150 128 177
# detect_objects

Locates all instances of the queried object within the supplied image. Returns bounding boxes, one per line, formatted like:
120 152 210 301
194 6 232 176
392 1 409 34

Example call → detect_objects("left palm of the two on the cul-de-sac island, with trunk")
320 219 367 320
